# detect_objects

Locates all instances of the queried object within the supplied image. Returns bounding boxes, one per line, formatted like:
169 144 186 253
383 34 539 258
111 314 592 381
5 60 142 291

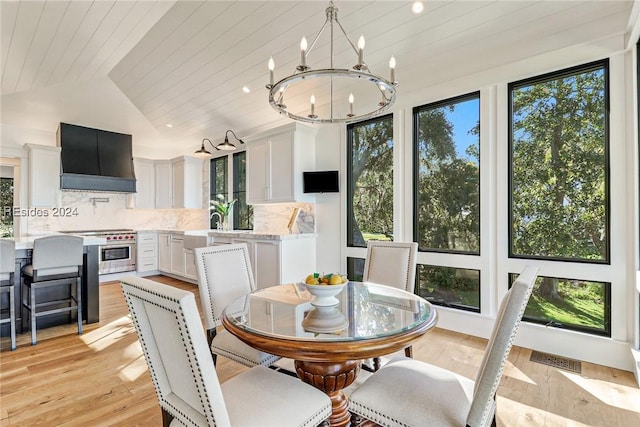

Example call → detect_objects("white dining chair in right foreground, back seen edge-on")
349 266 538 427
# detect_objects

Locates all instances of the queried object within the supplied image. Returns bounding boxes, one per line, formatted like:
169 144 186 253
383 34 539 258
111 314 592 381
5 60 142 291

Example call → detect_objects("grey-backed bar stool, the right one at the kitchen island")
22 235 83 345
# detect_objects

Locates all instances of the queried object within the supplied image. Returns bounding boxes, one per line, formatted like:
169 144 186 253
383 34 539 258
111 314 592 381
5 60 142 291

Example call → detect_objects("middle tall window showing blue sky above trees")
413 93 480 254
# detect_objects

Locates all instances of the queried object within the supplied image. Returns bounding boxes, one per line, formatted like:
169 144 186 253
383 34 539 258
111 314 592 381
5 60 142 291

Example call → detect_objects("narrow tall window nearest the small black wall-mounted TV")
347 115 393 247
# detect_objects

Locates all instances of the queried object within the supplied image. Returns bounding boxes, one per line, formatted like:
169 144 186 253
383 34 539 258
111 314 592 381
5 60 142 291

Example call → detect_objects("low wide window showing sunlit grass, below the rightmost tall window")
509 274 611 336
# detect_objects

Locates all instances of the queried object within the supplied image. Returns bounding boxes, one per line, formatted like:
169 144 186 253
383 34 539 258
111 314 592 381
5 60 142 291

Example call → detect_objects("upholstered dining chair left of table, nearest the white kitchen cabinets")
194 243 280 367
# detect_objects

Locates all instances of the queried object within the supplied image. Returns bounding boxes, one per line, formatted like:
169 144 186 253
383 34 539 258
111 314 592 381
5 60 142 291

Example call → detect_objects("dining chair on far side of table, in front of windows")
362 240 418 371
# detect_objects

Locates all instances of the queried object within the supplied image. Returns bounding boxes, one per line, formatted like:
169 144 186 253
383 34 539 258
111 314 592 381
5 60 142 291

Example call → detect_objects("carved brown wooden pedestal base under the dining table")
295 360 362 427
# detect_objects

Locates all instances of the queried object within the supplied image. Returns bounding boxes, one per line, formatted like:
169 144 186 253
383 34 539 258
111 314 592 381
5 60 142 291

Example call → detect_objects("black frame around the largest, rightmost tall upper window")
506 58 612 265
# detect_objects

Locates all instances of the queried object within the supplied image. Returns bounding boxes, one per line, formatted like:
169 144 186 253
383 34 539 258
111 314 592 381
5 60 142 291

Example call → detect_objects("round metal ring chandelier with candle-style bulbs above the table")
266 1 398 123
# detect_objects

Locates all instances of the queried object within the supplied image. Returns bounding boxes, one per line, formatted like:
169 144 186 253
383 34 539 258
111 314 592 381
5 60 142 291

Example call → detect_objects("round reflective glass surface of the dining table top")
223 282 436 343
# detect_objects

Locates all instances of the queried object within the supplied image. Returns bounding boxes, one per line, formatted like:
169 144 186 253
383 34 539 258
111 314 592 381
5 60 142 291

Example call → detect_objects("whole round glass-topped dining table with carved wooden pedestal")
222 282 437 426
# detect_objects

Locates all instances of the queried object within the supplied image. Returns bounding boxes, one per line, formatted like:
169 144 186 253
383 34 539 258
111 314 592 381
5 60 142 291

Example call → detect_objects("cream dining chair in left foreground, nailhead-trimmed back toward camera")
121 277 331 427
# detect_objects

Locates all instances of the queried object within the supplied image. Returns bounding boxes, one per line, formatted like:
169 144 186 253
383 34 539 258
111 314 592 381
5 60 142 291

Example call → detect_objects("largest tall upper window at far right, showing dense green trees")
509 61 609 263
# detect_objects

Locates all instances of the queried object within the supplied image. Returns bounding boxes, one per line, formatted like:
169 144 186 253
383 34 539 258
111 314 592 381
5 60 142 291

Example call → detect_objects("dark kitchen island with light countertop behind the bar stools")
3 233 106 334
